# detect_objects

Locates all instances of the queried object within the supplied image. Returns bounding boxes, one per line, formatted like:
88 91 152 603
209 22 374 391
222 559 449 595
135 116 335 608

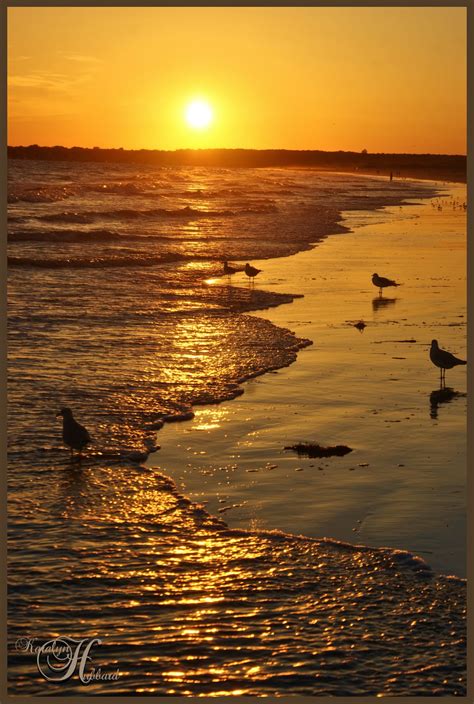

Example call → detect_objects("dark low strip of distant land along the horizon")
8 144 466 183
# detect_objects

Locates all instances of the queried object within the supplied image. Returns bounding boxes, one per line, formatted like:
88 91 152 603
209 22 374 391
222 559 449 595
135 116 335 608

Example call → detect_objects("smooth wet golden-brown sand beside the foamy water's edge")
148 186 466 576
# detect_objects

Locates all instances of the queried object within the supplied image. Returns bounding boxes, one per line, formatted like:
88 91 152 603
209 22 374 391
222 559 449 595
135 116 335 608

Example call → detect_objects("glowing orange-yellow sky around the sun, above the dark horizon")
8 7 466 154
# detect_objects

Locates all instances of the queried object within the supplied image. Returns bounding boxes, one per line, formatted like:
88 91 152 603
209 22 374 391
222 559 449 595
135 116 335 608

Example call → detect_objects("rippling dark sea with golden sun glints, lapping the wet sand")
9 162 465 696
